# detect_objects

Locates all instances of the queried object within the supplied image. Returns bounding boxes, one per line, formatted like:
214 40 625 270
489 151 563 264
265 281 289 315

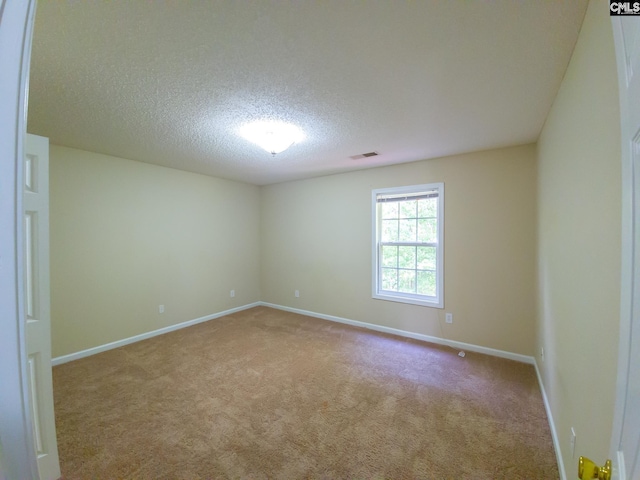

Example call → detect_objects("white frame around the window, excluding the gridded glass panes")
371 182 444 308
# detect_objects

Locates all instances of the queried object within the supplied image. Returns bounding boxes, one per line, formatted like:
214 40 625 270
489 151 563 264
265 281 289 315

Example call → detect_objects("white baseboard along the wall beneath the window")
258 302 535 365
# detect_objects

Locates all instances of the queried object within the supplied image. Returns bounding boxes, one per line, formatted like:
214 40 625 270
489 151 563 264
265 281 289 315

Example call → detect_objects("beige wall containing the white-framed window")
261 145 536 355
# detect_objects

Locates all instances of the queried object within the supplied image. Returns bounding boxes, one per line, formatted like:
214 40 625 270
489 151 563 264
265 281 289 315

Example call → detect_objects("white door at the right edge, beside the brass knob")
610 16 640 480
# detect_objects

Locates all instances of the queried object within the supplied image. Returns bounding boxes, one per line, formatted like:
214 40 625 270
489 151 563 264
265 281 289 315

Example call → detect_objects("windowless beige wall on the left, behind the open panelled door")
50 145 260 357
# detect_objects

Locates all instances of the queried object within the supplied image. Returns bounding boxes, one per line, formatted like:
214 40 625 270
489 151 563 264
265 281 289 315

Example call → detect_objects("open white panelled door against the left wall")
23 135 60 480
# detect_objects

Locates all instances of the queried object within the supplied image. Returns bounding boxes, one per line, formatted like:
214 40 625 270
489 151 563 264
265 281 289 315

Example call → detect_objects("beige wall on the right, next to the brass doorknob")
537 1 621 478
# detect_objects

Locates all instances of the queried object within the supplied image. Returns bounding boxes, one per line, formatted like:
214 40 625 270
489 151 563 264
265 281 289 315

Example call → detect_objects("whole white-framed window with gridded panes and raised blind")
373 183 444 308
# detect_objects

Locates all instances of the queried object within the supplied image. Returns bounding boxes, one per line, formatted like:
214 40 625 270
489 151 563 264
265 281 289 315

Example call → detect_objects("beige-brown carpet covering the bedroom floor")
53 307 558 480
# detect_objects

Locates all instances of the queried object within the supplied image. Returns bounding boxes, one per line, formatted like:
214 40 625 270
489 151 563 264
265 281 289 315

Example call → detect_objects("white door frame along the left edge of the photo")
0 0 38 479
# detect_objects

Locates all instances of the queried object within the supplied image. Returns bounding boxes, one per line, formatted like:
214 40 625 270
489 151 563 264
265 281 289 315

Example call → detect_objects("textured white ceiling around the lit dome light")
28 0 587 185
